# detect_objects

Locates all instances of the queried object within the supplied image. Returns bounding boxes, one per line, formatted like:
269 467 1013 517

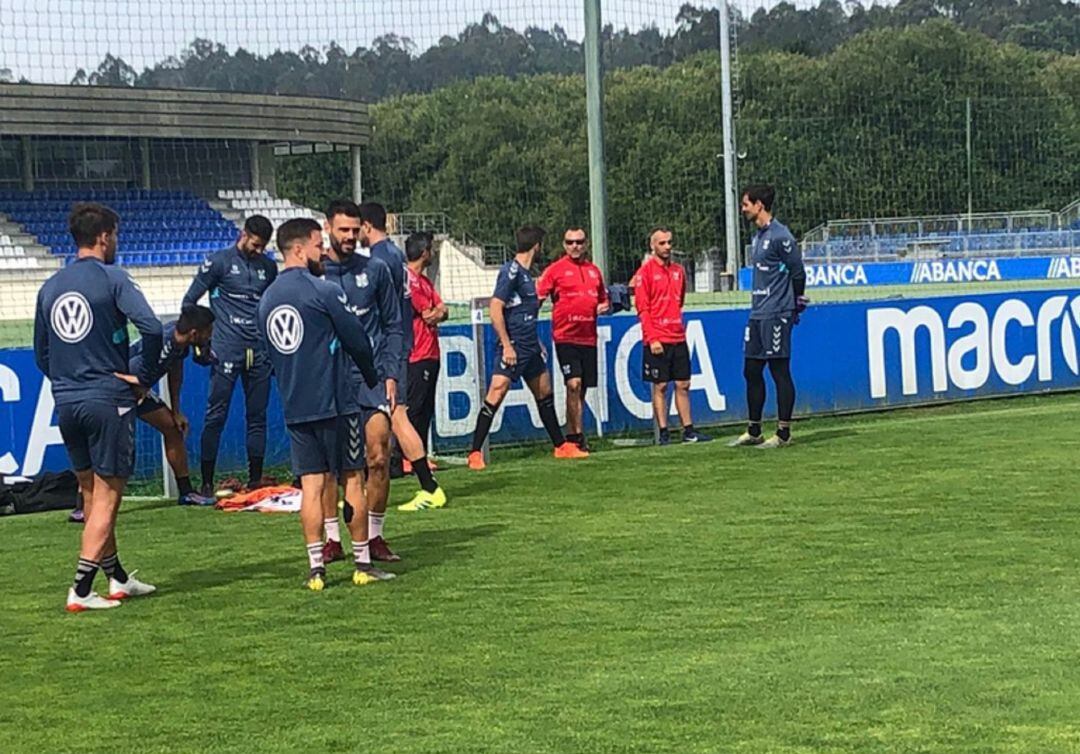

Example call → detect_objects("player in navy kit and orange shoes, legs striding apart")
469 225 589 471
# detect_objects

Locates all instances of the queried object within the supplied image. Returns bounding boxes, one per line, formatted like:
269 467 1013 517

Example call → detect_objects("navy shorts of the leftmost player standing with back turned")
56 401 135 479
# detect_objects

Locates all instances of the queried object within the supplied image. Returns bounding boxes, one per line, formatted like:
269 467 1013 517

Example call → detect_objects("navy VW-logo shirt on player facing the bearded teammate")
258 267 378 425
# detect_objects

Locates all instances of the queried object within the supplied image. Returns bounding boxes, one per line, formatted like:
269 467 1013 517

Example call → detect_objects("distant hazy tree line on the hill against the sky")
65 0 1080 95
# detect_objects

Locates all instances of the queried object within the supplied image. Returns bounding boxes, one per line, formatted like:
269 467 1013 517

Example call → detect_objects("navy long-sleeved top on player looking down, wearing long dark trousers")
184 244 278 354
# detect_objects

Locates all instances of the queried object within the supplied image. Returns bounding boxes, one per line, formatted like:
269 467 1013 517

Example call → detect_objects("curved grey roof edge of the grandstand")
0 83 372 146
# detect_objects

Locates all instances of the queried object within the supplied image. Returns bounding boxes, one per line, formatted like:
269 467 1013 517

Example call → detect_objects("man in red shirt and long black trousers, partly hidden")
399 232 450 479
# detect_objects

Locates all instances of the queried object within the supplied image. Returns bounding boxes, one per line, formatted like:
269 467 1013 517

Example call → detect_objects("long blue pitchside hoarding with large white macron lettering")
6 290 1080 475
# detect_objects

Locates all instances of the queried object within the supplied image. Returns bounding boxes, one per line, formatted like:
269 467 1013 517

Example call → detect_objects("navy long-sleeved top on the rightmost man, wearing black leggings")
750 220 806 320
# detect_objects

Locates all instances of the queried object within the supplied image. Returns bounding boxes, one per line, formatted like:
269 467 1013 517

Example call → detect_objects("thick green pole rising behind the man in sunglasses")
584 0 611 280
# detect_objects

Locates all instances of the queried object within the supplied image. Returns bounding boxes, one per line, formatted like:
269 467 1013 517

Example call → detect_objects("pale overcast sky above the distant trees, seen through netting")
0 0 808 83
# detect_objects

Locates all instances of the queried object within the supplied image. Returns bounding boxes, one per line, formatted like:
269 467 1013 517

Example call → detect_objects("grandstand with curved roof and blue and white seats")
0 84 370 322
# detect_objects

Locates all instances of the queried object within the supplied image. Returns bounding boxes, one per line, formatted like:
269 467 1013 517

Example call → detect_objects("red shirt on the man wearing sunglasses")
537 255 608 346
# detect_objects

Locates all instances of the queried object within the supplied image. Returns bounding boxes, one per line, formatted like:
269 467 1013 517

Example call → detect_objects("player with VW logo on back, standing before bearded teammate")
257 213 379 592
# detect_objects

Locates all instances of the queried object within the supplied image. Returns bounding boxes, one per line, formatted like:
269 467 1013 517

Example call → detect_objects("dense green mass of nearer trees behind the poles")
279 21 1080 274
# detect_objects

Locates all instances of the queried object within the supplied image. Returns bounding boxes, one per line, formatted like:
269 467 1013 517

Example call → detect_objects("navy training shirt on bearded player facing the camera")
323 254 402 416
